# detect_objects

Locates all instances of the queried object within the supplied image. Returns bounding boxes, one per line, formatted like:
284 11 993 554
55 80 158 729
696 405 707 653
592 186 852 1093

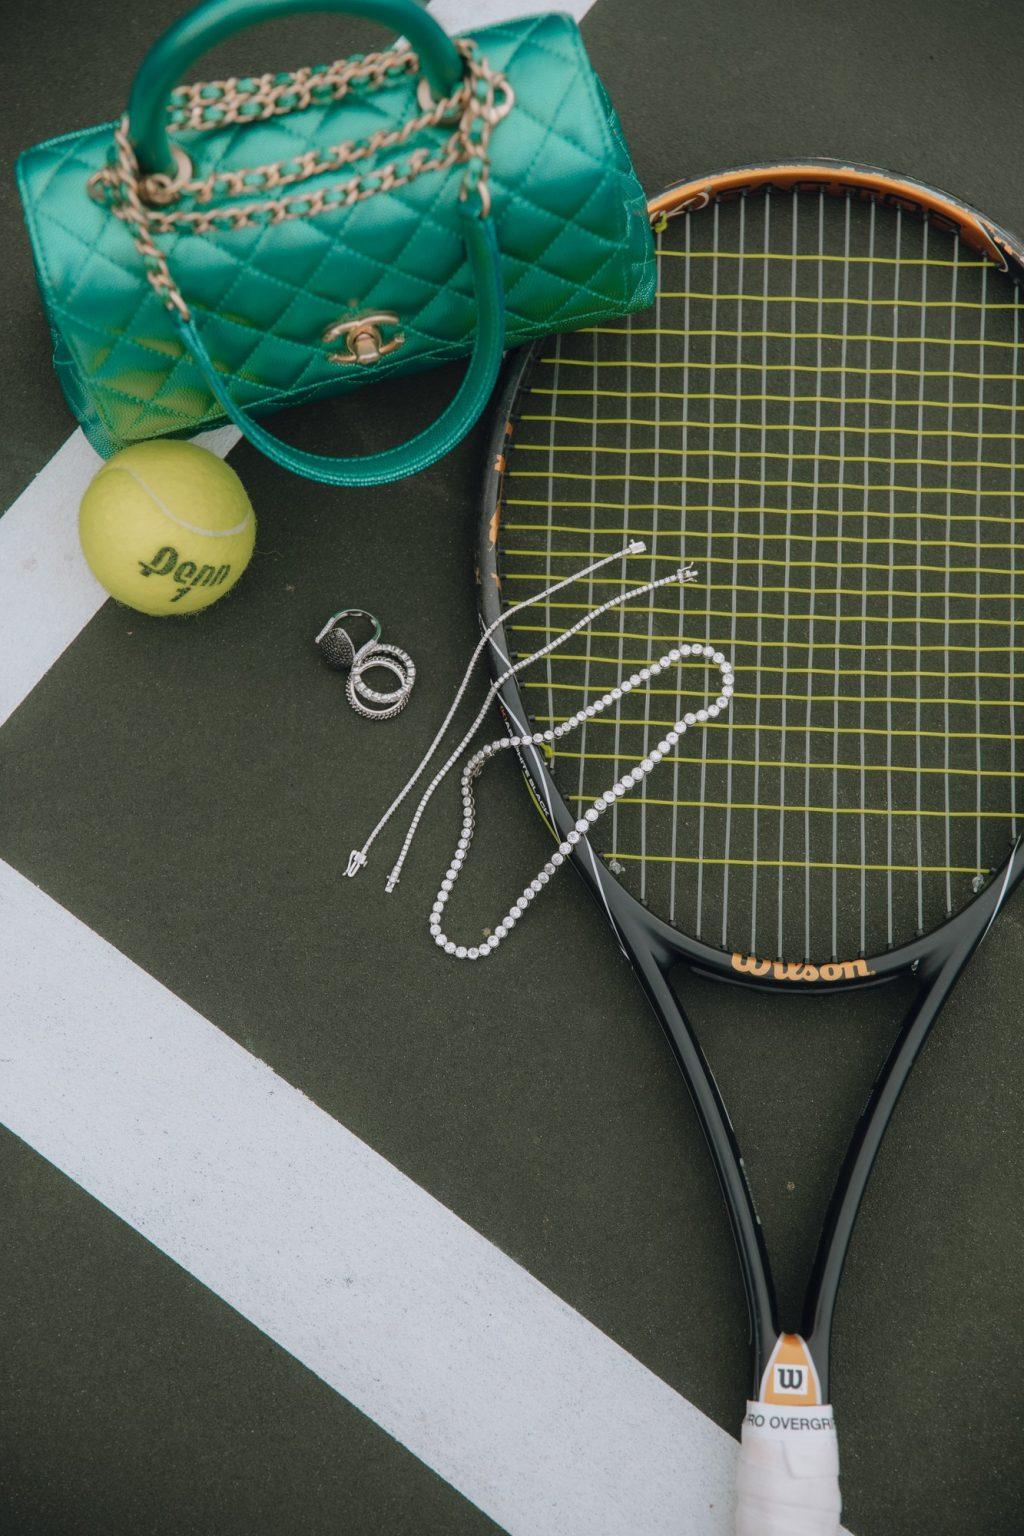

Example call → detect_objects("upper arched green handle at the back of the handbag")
127 0 464 177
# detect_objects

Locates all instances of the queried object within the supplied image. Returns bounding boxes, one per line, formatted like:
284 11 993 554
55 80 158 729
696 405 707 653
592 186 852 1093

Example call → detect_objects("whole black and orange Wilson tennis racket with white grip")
479 161 1024 1536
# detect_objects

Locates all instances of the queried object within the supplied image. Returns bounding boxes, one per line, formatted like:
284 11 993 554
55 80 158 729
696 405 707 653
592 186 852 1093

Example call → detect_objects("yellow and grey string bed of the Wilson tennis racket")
499 190 1024 958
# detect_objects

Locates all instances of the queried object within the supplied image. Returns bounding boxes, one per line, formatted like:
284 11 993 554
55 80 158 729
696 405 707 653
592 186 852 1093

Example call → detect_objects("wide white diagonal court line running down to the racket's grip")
0 863 737 1536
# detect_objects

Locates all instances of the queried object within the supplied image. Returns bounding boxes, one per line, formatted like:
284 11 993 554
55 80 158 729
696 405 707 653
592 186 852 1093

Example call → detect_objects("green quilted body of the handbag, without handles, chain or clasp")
18 14 654 455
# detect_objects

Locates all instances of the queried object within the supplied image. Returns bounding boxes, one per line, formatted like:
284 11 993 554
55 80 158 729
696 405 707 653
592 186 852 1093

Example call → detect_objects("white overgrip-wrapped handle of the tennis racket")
735 1402 841 1536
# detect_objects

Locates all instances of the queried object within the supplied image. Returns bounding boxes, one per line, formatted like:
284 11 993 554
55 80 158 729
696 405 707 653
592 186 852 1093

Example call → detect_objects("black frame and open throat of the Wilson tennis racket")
477 213 1024 1402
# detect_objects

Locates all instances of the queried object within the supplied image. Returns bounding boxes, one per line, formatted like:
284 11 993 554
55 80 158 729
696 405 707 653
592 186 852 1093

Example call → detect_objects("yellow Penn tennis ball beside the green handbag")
78 442 256 614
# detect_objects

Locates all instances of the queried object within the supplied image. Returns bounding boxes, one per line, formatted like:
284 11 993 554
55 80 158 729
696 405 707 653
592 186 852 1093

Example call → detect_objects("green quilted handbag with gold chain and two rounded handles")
18 0 654 485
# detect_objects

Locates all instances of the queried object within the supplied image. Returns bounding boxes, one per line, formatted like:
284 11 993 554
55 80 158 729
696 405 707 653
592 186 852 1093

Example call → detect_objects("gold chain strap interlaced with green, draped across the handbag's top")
89 38 514 321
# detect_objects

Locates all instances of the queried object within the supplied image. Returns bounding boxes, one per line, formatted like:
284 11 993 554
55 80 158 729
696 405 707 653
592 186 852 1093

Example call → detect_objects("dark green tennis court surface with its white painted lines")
0 0 1024 1536
